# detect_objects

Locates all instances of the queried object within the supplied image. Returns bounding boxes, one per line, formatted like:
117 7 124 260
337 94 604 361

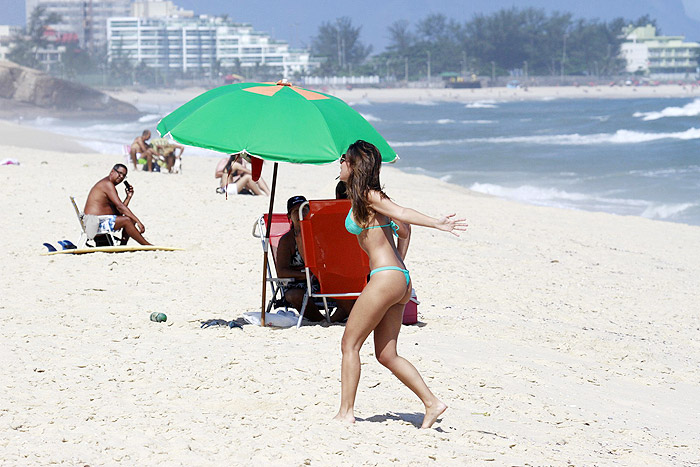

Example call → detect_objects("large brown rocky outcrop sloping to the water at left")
0 61 139 117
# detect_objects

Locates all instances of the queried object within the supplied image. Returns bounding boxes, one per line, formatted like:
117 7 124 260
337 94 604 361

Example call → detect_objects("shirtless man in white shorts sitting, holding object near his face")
83 164 150 245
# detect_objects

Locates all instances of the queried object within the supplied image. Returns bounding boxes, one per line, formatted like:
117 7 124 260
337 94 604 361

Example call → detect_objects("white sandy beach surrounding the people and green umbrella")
0 122 700 466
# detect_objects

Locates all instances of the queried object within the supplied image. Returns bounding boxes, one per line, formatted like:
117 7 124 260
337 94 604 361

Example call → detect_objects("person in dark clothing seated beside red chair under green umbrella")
277 195 354 322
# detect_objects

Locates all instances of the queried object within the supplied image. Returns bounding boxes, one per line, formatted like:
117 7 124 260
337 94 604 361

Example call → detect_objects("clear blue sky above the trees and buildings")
0 0 700 52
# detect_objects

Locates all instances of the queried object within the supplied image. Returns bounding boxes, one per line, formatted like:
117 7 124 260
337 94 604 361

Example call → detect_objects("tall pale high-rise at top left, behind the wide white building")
25 0 131 50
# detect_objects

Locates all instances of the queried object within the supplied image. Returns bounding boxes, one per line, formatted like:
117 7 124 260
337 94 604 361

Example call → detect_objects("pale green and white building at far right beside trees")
620 24 700 79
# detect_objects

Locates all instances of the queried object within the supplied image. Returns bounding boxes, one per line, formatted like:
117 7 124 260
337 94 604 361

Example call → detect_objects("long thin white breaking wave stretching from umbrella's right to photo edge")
391 128 700 147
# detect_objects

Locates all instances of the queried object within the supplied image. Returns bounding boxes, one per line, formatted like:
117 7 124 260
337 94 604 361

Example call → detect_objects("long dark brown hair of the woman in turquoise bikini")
345 140 388 226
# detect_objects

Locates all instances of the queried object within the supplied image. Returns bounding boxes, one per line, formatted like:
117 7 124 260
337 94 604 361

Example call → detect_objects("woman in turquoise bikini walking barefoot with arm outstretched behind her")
335 141 467 428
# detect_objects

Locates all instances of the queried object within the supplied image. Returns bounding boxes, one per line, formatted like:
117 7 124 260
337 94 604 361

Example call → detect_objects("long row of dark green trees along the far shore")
312 8 655 79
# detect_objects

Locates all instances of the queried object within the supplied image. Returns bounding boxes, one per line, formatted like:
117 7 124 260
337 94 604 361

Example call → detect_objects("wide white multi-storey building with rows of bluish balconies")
107 15 318 77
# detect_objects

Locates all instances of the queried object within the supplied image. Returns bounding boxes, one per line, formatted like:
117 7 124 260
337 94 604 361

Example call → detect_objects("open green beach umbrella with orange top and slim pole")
157 81 398 326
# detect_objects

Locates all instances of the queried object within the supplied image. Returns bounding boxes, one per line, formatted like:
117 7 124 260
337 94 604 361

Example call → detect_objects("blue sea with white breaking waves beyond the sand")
21 99 700 225
